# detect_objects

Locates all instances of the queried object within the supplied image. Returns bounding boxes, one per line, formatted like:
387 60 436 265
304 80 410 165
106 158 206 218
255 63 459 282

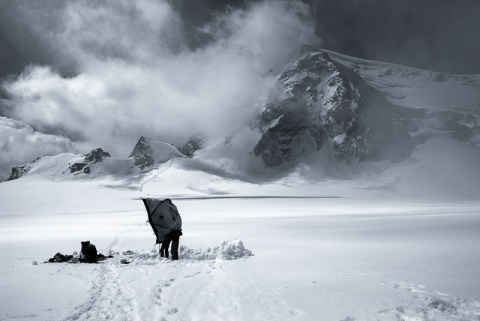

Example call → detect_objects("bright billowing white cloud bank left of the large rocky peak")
1 0 320 180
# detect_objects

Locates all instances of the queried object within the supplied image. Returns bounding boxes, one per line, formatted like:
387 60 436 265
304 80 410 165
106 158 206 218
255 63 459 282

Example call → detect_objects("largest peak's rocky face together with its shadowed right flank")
253 51 422 167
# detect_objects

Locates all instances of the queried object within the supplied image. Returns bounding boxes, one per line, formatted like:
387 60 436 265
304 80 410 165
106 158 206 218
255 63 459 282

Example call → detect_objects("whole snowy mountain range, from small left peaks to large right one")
4 46 480 195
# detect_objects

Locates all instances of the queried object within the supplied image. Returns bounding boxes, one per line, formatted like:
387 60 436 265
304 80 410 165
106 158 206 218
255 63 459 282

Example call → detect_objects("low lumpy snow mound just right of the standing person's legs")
179 240 253 260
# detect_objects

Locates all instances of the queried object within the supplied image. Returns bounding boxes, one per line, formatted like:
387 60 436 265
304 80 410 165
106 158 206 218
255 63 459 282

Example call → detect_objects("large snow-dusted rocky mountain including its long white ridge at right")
254 46 480 168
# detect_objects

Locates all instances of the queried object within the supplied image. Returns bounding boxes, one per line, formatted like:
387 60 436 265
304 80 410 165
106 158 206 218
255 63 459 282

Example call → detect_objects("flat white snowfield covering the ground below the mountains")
0 159 480 321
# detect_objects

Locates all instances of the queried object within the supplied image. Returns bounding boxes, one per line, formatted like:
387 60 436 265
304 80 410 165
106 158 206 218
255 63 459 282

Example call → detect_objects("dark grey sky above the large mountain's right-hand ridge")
312 0 480 73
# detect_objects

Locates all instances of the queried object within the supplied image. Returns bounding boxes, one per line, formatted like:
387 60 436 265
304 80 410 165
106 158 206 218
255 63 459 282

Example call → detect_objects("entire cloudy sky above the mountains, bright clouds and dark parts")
0 0 480 180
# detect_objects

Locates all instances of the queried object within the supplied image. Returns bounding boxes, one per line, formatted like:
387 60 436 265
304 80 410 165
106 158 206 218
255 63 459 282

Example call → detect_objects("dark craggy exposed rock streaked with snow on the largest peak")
254 52 368 167
